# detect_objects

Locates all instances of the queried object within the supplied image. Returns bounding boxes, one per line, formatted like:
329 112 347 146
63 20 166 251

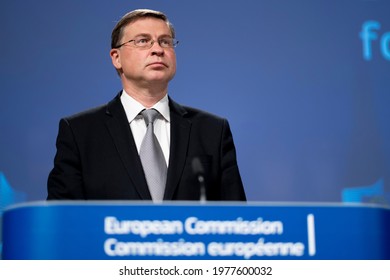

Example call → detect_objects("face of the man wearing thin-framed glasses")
110 18 176 86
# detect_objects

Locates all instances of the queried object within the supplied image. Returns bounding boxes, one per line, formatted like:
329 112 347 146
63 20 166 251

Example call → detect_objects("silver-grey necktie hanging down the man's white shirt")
140 109 167 201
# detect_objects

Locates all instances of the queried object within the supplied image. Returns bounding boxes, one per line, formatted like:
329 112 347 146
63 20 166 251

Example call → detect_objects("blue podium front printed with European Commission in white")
3 201 390 260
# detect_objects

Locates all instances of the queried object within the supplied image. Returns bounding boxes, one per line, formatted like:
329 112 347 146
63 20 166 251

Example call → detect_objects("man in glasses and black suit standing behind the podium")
47 10 246 201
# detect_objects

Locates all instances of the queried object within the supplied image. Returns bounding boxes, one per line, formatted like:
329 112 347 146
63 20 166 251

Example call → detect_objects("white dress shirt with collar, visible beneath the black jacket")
121 90 171 166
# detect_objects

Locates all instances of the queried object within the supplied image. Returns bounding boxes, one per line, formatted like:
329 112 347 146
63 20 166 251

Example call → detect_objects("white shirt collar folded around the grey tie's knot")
121 90 171 123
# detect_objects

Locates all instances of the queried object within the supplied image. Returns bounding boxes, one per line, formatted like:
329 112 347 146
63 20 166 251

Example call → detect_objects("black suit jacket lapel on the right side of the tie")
164 99 191 200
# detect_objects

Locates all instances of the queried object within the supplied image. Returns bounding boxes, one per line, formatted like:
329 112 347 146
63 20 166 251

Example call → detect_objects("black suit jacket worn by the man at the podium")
47 94 246 200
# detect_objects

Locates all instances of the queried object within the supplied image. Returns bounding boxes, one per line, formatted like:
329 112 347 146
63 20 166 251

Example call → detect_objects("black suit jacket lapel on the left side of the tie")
106 94 151 200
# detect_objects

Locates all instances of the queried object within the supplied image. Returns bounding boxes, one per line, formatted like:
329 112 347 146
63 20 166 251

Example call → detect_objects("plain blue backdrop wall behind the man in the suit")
0 0 390 206
